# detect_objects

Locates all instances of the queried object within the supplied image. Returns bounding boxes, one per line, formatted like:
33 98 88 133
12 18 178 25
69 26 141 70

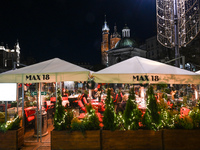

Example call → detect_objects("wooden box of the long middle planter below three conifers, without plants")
102 130 162 150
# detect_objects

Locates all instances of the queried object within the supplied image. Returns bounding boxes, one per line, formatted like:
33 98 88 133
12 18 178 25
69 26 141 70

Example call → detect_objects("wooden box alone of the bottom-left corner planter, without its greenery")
0 127 24 150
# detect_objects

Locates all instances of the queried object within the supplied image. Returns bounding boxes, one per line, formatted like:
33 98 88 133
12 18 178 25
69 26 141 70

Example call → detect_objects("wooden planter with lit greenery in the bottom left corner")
0 116 24 149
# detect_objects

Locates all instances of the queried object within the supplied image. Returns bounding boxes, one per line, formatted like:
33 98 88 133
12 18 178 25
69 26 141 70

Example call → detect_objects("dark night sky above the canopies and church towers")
0 0 156 65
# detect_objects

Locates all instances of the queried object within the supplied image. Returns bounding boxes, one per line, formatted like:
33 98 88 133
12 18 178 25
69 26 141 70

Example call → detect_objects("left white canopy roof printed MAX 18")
0 58 90 83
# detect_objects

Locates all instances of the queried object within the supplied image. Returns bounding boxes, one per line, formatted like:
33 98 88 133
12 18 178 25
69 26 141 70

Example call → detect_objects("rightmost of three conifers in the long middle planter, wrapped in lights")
142 86 161 130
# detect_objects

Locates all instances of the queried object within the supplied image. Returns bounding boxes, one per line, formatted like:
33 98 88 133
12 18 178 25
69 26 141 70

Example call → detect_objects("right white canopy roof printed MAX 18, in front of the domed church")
93 56 200 84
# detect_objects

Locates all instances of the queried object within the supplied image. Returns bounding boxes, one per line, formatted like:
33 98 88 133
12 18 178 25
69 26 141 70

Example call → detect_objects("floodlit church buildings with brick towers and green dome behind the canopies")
101 18 146 66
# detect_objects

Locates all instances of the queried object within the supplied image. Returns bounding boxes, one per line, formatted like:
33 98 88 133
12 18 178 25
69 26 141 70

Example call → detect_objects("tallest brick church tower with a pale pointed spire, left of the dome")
101 16 110 65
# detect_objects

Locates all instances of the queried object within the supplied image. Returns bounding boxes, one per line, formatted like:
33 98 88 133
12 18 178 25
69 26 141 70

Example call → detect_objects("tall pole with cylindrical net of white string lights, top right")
156 0 200 67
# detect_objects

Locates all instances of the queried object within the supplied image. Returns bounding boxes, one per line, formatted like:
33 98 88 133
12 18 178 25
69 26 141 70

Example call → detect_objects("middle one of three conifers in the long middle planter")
124 88 142 130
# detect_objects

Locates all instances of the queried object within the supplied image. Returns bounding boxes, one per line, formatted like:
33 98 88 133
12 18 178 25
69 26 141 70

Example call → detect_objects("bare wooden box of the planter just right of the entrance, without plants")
51 130 100 150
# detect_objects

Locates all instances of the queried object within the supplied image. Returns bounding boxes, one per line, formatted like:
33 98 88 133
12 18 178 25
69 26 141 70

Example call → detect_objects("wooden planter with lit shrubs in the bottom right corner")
163 107 200 150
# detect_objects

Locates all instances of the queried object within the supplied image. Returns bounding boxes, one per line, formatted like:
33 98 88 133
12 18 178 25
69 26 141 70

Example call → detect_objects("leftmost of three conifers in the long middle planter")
103 89 116 131
